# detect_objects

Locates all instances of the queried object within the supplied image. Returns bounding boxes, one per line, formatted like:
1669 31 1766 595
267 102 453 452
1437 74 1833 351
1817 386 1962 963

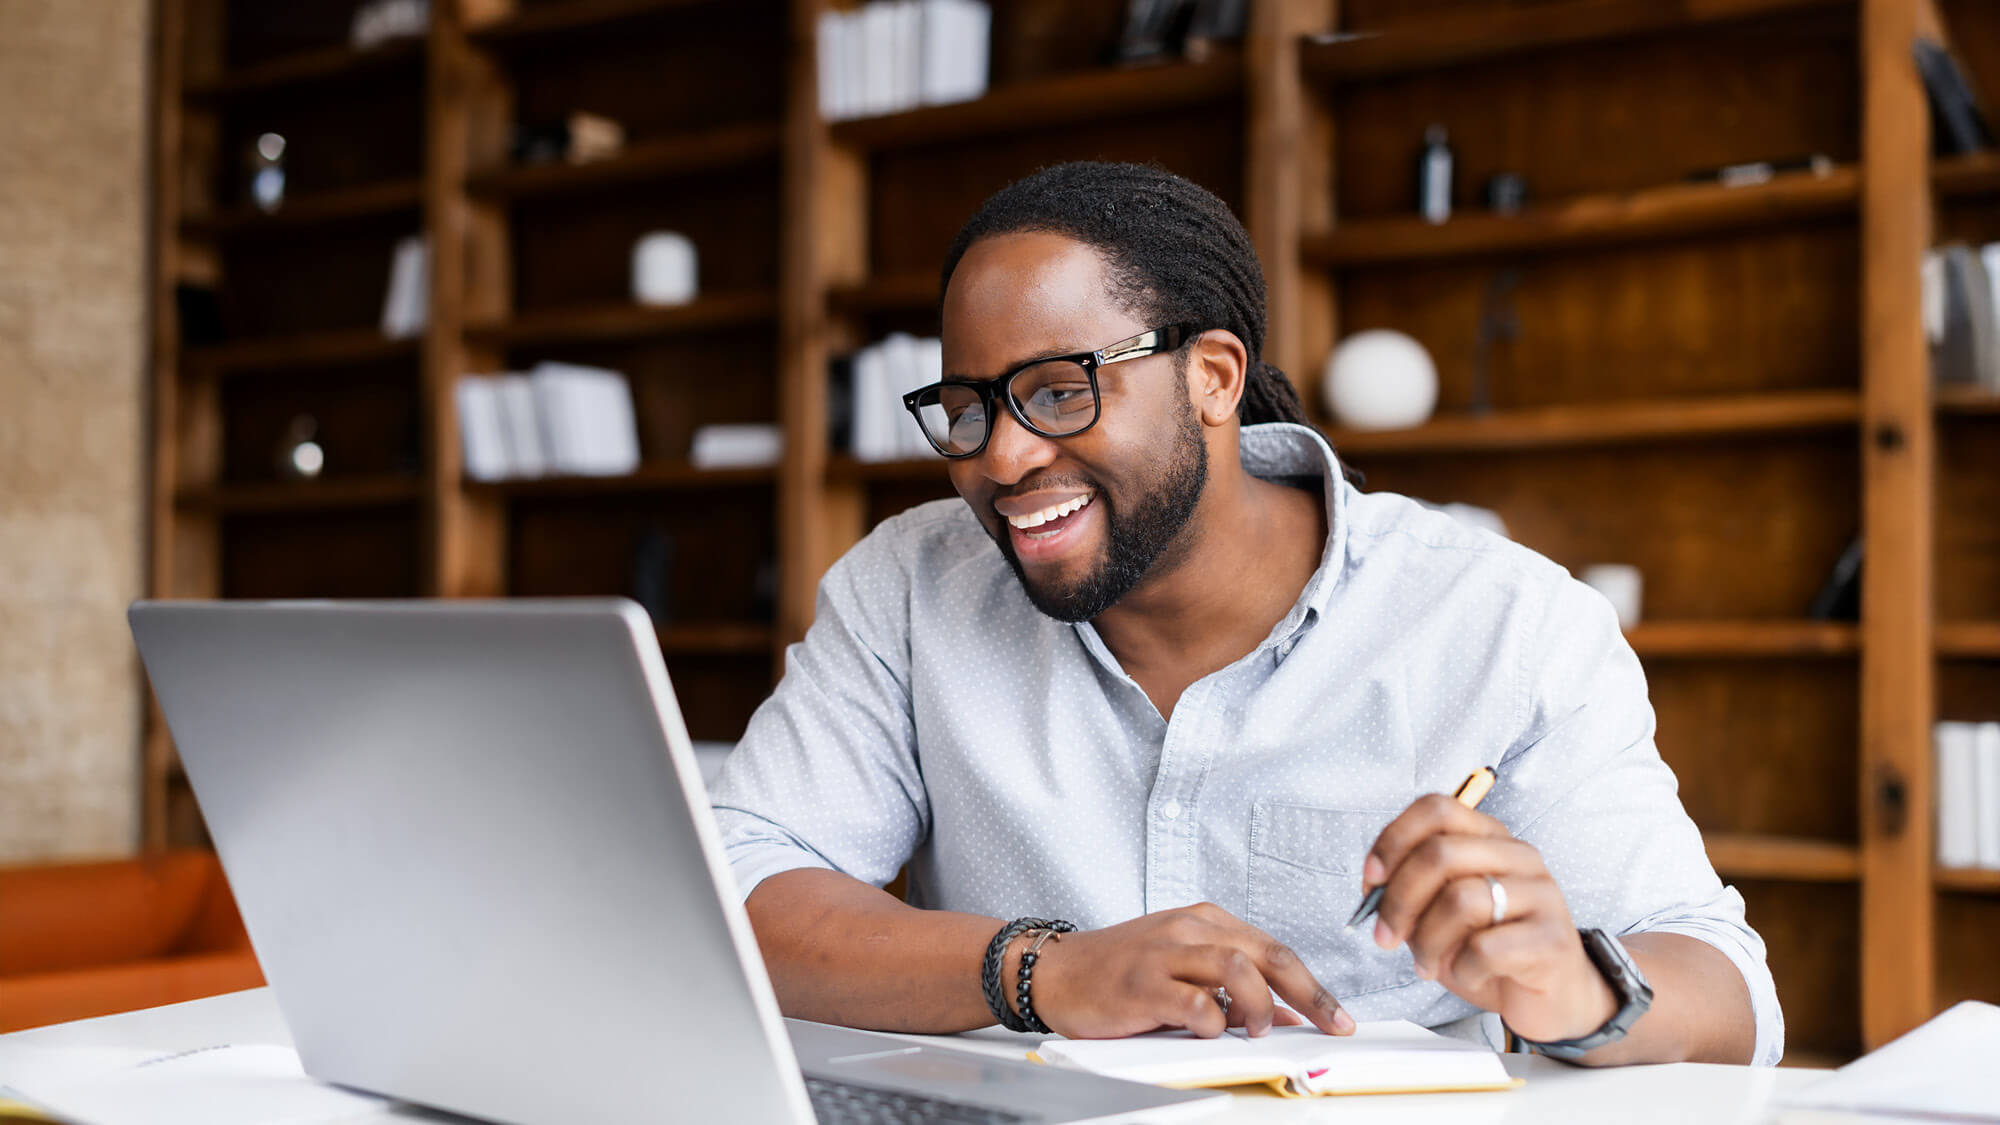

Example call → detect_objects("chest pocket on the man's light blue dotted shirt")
1244 801 1418 1003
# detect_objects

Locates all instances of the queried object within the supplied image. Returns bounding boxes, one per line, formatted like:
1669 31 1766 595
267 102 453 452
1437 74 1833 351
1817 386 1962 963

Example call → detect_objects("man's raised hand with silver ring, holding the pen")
1362 793 1618 1043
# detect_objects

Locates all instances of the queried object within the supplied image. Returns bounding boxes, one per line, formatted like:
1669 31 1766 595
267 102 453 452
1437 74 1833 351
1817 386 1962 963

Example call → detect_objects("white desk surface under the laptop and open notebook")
0 989 1822 1125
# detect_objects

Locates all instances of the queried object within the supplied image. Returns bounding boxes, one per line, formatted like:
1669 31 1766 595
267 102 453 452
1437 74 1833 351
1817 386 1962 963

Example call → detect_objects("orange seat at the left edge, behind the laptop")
0 851 264 1031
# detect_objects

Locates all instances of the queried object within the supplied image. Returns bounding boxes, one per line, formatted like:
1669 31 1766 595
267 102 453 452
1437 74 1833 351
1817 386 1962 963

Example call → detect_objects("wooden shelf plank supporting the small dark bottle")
1300 166 1860 268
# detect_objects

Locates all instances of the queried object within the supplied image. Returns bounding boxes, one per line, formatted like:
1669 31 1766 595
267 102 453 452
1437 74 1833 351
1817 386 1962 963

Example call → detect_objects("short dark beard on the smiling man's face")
994 398 1208 625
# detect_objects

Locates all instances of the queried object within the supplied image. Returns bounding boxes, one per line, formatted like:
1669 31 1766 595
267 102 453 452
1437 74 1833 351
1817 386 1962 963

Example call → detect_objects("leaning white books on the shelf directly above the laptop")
454 362 640 480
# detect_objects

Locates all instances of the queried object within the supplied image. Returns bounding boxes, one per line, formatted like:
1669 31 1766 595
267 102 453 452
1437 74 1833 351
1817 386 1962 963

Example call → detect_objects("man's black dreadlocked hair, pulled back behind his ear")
938 162 1312 426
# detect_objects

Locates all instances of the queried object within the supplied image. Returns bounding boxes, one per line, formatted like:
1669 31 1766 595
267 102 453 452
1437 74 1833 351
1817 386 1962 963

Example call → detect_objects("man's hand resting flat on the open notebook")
1004 903 1354 1039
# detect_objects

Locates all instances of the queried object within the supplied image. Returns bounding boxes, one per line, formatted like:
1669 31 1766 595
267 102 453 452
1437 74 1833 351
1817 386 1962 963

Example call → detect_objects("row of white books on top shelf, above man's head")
818 0 992 120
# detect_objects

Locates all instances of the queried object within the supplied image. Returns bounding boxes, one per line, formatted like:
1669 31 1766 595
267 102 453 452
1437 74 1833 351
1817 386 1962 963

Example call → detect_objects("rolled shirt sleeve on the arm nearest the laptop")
710 520 930 899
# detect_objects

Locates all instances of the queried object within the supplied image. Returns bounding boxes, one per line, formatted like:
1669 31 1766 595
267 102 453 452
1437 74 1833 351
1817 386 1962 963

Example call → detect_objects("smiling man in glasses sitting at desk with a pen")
714 164 1782 1063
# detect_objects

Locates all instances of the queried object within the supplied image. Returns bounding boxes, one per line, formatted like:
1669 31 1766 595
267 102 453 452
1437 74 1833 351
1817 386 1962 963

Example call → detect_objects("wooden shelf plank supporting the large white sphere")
1328 390 1862 456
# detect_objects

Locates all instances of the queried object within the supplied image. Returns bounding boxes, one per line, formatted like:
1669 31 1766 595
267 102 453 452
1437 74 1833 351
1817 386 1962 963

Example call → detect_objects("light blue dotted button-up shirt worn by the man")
714 424 1784 1065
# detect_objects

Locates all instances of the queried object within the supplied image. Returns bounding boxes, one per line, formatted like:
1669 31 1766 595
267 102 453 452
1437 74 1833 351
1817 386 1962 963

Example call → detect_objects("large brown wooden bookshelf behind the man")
146 0 2000 1059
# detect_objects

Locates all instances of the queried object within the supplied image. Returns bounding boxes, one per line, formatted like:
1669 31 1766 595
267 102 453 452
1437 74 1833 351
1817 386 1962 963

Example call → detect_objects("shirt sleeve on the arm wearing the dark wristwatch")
1494 577 1784 1065
